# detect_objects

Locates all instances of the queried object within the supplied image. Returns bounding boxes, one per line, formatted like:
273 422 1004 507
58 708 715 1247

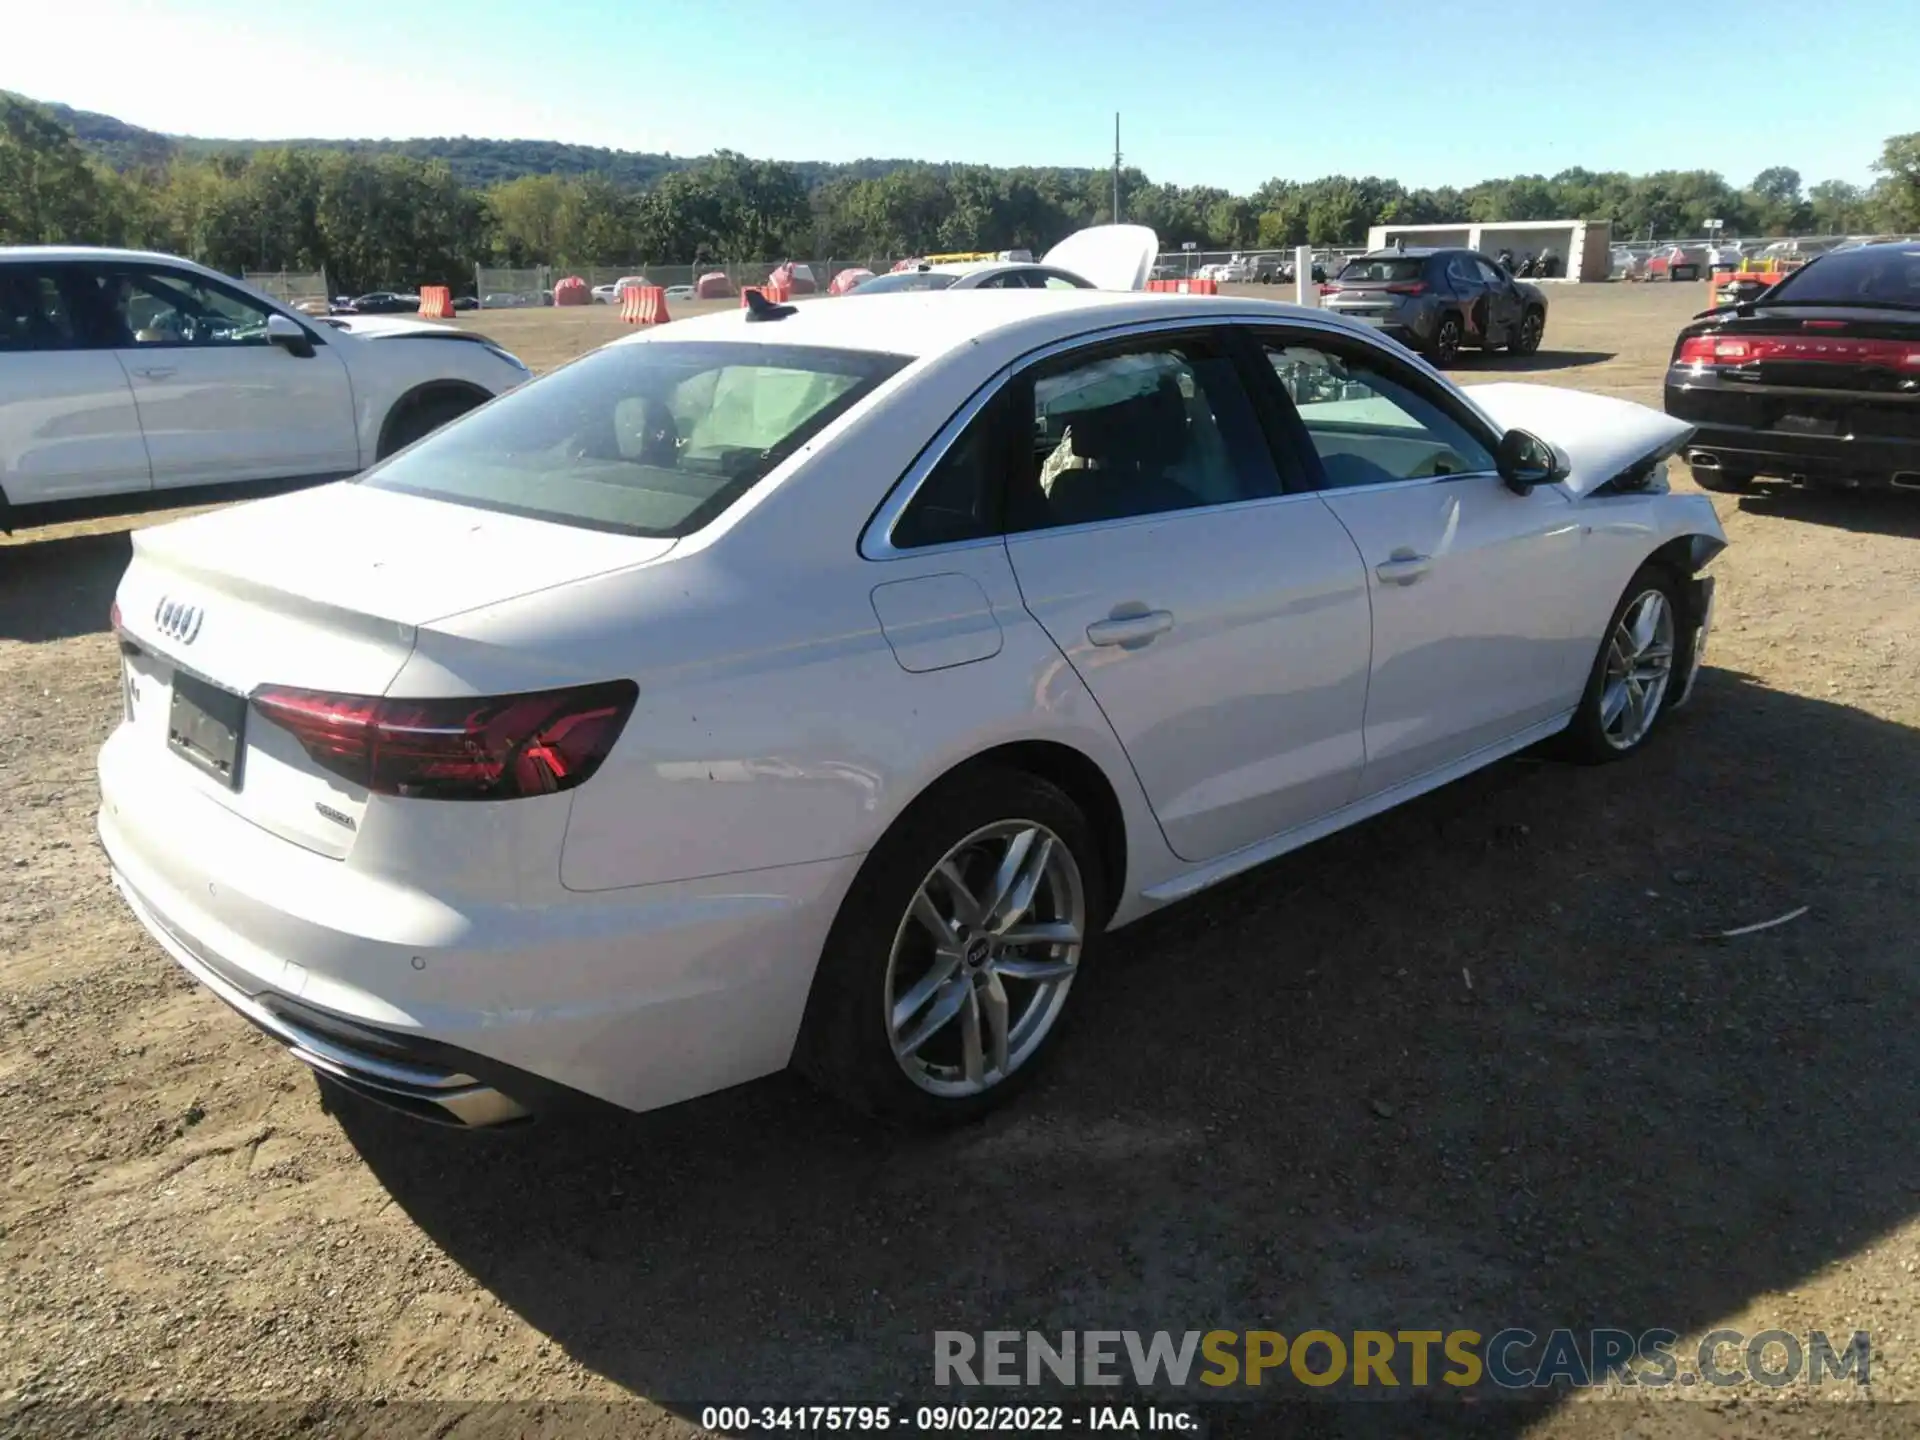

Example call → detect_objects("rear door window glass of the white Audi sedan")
1008 340 1281 530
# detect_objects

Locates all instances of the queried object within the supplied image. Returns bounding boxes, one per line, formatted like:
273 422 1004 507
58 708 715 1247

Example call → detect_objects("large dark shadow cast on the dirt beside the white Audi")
330 670 1920 1436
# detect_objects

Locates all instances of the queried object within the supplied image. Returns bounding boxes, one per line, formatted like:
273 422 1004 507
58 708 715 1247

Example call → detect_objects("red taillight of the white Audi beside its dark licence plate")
253 680 639 801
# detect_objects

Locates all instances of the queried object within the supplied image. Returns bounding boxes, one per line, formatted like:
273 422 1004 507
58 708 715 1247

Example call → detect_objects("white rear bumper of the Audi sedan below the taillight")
100 730 860 1125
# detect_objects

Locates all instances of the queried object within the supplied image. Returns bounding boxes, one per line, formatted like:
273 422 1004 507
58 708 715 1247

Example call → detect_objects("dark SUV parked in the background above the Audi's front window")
1321 246 1548 365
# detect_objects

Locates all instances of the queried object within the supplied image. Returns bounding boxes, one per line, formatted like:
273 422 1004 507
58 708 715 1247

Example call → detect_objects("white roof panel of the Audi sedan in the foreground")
612 290 1373 357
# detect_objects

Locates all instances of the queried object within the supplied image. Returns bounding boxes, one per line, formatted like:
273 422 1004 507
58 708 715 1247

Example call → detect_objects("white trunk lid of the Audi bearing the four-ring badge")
117 484 674 858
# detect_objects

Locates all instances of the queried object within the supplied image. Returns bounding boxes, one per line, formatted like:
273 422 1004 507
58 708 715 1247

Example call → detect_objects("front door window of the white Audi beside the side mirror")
1265 342 1494 490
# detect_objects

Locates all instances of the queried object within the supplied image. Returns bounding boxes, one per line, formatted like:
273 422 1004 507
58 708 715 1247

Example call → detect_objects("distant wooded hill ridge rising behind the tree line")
40 102 1091 188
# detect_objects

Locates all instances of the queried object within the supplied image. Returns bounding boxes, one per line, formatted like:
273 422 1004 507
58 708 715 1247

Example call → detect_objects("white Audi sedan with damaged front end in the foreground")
100 290 1726 1125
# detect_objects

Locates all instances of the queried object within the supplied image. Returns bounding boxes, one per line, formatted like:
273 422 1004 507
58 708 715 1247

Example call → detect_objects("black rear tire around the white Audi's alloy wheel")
793 766 1108 1127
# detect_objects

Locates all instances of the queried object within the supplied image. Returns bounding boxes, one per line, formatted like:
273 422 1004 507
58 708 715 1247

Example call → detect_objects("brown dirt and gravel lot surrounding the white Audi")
0 286 1920 1438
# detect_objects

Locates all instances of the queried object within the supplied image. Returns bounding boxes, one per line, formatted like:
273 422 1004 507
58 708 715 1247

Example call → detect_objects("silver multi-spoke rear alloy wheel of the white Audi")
885 820 1087 1098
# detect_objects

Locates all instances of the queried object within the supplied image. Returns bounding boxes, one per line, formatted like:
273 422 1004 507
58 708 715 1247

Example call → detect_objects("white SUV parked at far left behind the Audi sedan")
0 246 530 530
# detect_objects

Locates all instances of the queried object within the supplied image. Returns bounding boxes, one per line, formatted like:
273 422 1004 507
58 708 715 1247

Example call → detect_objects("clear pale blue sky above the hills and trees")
0 0 1920 192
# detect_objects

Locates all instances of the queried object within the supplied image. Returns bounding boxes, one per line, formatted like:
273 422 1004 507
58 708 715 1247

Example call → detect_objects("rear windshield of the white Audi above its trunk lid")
359 340 906 538
